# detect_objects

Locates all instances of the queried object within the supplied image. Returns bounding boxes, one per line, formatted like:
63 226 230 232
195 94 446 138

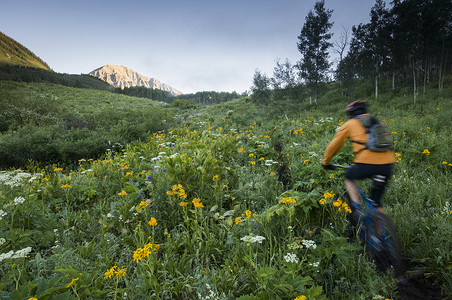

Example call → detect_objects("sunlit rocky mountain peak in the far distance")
89 65 182 96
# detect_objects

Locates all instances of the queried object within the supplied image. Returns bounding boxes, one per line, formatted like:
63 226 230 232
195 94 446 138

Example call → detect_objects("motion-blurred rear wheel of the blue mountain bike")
365 213 405 276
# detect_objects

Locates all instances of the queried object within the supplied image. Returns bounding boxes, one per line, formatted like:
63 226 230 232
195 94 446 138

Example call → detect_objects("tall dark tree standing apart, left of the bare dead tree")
298 0 333 103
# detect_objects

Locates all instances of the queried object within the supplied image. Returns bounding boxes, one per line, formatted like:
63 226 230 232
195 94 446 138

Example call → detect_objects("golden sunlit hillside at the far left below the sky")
0 32 50 70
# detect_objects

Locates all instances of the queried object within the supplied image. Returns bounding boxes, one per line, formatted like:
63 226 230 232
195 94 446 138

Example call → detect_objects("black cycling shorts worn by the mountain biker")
345 163 393 207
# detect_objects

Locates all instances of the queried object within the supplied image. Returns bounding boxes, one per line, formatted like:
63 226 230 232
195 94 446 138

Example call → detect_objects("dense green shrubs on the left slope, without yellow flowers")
0 81 174 168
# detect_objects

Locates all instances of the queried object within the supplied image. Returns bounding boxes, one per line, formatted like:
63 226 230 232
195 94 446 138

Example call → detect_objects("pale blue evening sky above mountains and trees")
0 0 375 93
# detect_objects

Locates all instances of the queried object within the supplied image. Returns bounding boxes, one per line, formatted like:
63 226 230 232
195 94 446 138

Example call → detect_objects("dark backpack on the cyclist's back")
352 116 394 153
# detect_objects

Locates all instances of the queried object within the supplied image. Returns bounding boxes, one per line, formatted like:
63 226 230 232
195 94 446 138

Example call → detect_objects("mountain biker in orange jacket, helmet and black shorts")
322 101 396 219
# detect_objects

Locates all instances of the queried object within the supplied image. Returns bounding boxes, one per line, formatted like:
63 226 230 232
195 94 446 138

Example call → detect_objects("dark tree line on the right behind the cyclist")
251 0 452 102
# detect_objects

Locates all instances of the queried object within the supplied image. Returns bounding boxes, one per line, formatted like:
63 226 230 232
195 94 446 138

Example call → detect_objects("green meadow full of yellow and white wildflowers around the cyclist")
0 81 452 300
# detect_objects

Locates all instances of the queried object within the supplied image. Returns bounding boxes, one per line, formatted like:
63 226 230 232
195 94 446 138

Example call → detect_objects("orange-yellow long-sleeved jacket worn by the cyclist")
322 115 396 165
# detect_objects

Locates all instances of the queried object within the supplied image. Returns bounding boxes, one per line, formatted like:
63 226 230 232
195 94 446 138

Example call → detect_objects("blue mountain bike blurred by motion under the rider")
330 165 405 276
